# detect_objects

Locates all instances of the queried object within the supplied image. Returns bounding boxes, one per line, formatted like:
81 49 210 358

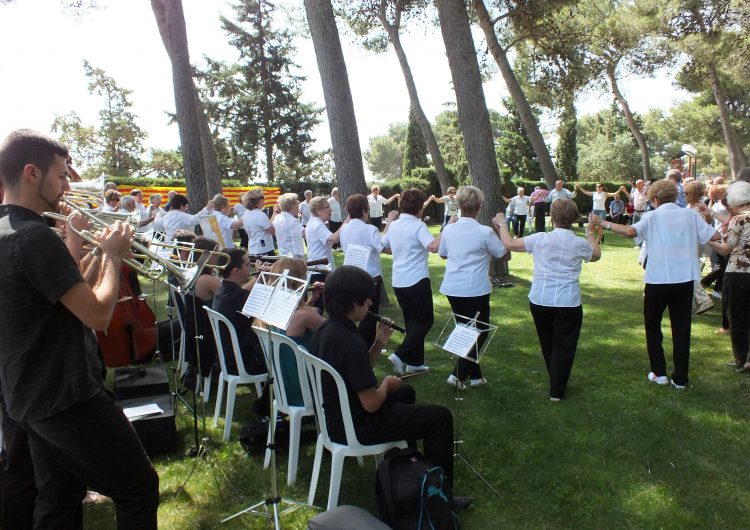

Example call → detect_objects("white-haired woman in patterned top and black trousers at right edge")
710 180 750 371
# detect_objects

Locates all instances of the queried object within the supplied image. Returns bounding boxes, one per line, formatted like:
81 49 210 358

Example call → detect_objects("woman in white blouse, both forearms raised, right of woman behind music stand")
499 199 601 401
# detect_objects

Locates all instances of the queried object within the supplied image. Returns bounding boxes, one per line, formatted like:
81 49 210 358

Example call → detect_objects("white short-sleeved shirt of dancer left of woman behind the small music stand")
381 213 435 287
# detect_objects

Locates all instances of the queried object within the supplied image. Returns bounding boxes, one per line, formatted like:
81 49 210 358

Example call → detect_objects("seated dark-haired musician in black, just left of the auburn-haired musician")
211 248 266 375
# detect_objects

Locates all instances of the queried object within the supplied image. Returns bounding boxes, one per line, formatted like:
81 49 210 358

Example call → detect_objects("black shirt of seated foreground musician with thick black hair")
310 317 384 442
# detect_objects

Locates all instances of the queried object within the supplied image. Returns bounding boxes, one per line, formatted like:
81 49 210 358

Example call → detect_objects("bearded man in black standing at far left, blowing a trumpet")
0 129 159 529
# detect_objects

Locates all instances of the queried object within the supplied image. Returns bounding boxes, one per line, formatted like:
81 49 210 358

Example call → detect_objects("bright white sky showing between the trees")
0 0 689 174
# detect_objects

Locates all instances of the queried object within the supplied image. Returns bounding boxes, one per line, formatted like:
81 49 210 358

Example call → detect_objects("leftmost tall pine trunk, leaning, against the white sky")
151 0 208 211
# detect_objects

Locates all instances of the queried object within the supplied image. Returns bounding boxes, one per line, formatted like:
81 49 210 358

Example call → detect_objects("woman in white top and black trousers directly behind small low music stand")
438 186 508 390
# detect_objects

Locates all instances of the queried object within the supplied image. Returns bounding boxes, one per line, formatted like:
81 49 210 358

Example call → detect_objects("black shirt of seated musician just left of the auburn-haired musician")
211 280 266 375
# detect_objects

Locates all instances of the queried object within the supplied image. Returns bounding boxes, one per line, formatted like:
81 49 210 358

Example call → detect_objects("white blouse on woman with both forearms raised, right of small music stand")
523 228 593 307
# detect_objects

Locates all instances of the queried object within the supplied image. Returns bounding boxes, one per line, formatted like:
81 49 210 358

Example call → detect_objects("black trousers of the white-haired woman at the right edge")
721 272 750 364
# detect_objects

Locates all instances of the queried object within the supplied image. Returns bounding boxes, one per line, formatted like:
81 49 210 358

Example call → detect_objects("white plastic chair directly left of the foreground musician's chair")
254 327 315 486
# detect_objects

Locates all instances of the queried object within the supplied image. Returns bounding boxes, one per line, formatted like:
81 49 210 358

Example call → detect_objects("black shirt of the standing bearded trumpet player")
0 205 103 421
